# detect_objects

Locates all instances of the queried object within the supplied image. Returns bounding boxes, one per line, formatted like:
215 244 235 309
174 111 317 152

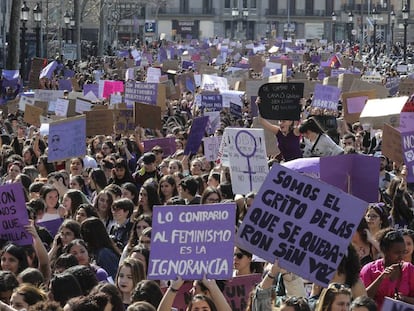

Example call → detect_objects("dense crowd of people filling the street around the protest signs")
0 36 414 311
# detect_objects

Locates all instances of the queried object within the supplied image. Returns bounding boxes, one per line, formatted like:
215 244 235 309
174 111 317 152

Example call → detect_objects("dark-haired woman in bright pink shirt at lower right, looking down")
360 229 414 310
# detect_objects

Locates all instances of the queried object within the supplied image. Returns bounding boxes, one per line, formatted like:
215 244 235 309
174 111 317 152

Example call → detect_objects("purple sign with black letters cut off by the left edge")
0 183 33 245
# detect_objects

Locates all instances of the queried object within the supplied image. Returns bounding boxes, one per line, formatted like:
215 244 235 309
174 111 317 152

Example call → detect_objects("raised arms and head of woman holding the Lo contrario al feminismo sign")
157 277 231 311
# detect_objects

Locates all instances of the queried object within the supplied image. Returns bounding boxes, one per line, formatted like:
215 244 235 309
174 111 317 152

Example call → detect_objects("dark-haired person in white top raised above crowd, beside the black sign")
299 117 344 158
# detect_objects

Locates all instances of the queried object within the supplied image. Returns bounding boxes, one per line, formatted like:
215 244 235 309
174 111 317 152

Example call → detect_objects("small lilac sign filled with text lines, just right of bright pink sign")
125 81 158 105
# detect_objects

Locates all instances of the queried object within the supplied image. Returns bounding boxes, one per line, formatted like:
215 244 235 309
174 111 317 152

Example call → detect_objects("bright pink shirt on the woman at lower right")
360 259 414 310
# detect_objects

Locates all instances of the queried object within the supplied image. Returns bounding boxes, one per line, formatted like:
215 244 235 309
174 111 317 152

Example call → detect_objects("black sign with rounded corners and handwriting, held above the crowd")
259 83 304 120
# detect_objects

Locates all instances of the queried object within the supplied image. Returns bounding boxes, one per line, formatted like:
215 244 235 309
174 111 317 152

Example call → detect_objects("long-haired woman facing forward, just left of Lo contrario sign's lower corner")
116 258 145 308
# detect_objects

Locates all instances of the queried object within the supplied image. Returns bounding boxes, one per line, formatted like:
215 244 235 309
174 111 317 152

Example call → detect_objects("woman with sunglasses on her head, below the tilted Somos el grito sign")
316 283 352 311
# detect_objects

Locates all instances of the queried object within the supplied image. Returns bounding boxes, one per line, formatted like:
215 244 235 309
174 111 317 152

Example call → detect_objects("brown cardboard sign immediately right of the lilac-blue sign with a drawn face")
85 109 114 136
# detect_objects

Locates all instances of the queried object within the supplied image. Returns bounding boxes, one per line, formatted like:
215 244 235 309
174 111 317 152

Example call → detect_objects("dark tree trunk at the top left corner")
5 0 22 70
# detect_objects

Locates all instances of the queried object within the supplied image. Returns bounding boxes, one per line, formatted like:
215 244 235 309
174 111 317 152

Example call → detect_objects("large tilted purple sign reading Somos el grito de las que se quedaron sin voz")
236 164 368 287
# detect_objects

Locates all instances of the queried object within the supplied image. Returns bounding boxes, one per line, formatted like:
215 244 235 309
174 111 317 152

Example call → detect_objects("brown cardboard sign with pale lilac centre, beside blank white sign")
341 90 376 123
